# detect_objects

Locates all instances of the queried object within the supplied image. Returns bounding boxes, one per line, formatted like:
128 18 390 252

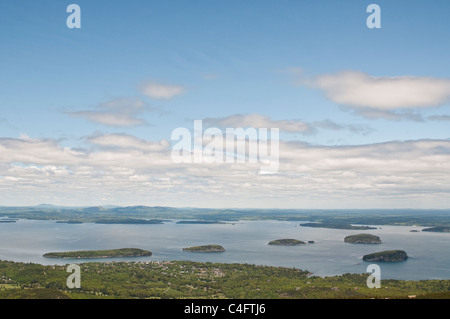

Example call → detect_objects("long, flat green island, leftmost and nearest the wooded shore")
43 248 152 258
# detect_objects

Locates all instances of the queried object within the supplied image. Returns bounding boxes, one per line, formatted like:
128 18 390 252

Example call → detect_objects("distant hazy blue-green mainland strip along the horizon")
0 205 450 229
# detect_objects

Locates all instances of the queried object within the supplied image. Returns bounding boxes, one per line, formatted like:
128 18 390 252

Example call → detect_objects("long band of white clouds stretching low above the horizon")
0 134 450 208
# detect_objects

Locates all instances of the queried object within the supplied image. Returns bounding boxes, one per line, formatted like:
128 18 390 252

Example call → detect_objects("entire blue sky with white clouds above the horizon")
0 0 450 209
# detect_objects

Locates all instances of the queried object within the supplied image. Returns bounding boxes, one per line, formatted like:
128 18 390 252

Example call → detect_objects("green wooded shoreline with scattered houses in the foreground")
0 261 450 299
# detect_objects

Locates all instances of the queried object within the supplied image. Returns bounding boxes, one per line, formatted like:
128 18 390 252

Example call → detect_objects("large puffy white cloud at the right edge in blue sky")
298 71 450 120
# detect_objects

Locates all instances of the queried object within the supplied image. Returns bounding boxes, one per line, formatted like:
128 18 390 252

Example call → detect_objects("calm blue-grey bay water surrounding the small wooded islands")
0 220 450 280
